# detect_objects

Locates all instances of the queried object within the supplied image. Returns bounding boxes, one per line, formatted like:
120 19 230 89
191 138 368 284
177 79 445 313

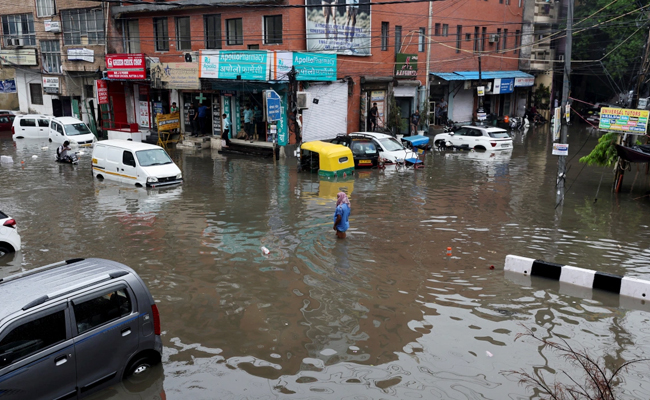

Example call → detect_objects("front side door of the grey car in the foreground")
0 302 77 400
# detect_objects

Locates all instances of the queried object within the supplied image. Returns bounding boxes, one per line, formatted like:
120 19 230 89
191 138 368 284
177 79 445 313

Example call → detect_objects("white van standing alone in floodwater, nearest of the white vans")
93 140 183 187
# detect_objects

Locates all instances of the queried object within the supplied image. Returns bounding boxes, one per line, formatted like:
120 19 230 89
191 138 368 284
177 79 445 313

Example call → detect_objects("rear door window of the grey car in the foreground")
74 288 135 335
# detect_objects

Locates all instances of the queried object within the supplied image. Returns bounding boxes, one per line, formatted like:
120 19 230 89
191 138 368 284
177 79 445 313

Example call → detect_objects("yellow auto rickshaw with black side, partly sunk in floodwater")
298 140 354 177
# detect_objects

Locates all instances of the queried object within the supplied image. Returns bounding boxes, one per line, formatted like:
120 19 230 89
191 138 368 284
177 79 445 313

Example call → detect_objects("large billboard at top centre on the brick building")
305 0 370 56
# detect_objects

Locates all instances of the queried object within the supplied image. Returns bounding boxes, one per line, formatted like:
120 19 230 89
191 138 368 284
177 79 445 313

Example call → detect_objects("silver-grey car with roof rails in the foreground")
0 258 162 400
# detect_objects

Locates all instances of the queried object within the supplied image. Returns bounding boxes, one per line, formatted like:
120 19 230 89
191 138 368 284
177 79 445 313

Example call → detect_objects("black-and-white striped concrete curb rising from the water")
504 255 650 300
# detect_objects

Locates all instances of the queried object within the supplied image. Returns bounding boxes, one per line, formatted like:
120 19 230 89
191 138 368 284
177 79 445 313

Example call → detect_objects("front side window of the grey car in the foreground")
0 310 66 368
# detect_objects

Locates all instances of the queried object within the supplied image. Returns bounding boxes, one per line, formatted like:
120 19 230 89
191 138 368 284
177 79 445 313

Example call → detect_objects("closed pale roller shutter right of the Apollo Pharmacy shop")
302 82 348 142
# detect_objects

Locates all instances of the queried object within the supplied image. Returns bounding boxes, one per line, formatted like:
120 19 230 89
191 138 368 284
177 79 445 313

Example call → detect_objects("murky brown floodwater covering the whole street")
0 126 650 399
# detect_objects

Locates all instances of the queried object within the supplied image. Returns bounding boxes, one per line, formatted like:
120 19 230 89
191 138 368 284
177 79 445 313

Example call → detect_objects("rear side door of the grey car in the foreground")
70 283 140 395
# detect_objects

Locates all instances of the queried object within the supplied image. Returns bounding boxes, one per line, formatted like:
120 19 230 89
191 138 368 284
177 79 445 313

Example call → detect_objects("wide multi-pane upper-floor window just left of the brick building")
61 9 104 45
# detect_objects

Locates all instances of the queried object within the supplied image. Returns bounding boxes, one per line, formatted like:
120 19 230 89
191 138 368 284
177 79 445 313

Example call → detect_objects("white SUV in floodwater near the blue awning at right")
433 126 512 151
